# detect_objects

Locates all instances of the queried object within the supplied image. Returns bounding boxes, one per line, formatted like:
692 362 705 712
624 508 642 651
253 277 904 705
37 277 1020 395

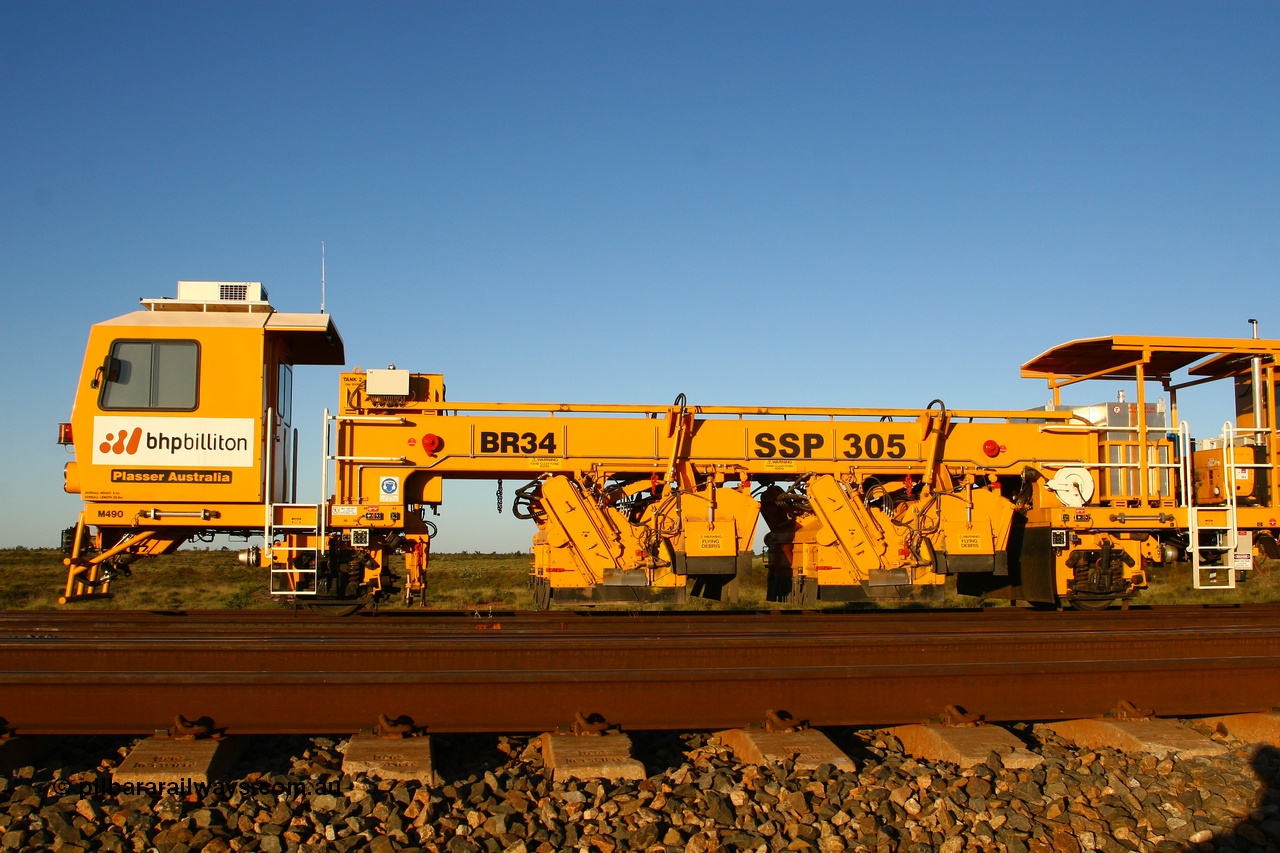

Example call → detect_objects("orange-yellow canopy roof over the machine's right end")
1021 336 1280 387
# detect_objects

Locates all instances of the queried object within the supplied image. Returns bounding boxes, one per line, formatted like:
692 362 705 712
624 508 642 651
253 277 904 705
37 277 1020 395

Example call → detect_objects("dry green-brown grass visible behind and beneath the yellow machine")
0 548 1280 610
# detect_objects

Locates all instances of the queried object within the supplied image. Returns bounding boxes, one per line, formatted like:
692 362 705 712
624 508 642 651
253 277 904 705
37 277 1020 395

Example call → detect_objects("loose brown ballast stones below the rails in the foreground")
0 725 1280 853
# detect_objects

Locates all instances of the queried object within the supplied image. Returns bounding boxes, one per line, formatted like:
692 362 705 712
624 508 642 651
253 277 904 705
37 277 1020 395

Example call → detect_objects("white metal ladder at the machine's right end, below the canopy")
1179 421 1239 589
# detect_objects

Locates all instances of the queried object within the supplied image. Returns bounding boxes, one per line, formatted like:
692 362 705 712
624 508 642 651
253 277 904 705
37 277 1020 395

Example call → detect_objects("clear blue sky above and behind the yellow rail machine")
0 3 1280 551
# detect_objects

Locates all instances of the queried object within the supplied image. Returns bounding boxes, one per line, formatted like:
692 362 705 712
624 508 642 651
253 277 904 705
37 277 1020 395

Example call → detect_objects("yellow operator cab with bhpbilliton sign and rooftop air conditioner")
59 282 346 599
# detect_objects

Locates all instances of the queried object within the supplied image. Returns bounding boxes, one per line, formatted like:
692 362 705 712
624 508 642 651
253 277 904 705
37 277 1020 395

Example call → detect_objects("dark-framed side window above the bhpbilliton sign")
99 341 200 411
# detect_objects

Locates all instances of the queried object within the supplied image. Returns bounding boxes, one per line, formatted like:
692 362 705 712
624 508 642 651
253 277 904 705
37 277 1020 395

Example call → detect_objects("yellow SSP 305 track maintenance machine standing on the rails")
59 282 1280 608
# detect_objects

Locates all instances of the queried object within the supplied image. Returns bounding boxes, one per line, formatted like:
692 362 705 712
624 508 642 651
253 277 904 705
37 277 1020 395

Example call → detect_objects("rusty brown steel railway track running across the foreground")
0 606 1280 734
